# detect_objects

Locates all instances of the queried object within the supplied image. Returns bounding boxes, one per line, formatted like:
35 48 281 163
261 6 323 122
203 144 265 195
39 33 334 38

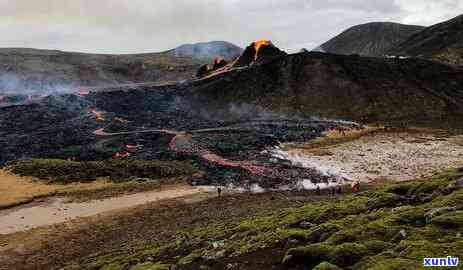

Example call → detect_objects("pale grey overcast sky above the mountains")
0 0 463 53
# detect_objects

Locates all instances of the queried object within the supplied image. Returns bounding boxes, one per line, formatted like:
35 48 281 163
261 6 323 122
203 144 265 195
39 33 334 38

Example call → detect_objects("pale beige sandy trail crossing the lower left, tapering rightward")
0 185 213 234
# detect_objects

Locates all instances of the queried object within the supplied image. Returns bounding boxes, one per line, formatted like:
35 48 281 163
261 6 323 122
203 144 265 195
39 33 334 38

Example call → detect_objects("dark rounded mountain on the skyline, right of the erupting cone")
317 22 425 56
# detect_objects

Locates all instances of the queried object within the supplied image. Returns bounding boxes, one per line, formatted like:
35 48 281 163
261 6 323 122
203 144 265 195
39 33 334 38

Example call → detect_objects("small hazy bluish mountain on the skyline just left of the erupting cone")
167 41 243 61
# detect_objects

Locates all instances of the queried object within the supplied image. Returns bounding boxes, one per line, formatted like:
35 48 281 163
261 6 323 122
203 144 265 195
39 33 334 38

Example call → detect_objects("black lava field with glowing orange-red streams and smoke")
0 81 357 188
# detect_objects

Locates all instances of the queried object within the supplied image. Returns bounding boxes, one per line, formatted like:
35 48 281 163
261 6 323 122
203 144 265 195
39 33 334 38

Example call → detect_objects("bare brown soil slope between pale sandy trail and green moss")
0 190 332 270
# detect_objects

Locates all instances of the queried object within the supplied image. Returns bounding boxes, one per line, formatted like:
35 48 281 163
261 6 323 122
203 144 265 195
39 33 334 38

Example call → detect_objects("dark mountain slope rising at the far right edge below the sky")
391 15 463 65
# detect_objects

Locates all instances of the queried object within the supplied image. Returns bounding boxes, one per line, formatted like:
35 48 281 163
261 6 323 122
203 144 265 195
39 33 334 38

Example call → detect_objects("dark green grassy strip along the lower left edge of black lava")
8 159 194 184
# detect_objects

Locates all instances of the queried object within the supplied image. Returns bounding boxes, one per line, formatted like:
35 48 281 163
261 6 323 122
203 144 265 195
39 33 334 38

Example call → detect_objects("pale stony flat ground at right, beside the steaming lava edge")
280 132 463 182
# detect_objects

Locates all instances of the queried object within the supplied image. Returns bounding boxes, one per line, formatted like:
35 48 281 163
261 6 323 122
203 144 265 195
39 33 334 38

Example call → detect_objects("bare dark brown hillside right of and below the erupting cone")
194 53 463 129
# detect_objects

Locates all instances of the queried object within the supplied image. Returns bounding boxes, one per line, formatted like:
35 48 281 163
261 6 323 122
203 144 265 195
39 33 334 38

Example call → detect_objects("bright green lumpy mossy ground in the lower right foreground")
60 170 463 270
